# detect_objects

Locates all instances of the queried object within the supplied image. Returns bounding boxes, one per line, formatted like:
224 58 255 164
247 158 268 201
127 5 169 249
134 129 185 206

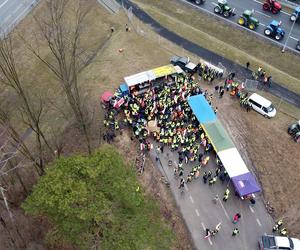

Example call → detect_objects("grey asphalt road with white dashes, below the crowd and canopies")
146 143 274 250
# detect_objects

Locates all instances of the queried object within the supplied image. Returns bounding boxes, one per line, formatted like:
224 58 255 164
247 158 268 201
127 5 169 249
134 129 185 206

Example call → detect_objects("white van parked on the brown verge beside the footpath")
248 93 276 118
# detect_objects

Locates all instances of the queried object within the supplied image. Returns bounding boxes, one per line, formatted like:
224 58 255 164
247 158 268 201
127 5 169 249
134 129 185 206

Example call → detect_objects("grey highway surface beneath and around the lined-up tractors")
181 0 300 54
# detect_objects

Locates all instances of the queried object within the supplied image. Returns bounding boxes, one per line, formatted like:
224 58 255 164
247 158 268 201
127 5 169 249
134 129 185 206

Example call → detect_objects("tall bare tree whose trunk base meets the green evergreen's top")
27 0 94 154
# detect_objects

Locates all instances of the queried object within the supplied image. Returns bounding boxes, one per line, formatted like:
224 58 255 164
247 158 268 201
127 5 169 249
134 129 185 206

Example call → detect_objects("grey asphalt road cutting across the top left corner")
0 0 39 37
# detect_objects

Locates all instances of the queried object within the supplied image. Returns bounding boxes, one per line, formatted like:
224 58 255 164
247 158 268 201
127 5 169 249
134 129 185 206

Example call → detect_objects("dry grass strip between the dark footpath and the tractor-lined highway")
134 0 300 93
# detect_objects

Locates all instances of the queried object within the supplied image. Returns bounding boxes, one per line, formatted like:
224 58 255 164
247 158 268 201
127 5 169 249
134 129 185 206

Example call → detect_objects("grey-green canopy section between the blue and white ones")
202 120 234 153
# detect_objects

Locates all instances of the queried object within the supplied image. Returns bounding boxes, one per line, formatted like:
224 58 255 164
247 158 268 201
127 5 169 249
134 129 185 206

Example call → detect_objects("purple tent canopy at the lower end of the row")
231 172 261 197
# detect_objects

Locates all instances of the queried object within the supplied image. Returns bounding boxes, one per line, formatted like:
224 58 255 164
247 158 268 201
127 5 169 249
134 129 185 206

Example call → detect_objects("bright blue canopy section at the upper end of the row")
188 95 217 124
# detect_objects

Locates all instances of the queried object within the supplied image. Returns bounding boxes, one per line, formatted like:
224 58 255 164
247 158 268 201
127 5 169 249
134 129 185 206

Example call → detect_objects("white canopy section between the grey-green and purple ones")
218 148 249 178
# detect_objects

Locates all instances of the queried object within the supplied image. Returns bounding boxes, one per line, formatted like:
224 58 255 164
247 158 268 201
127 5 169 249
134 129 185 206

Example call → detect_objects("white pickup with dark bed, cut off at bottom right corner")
258 235 300 250
